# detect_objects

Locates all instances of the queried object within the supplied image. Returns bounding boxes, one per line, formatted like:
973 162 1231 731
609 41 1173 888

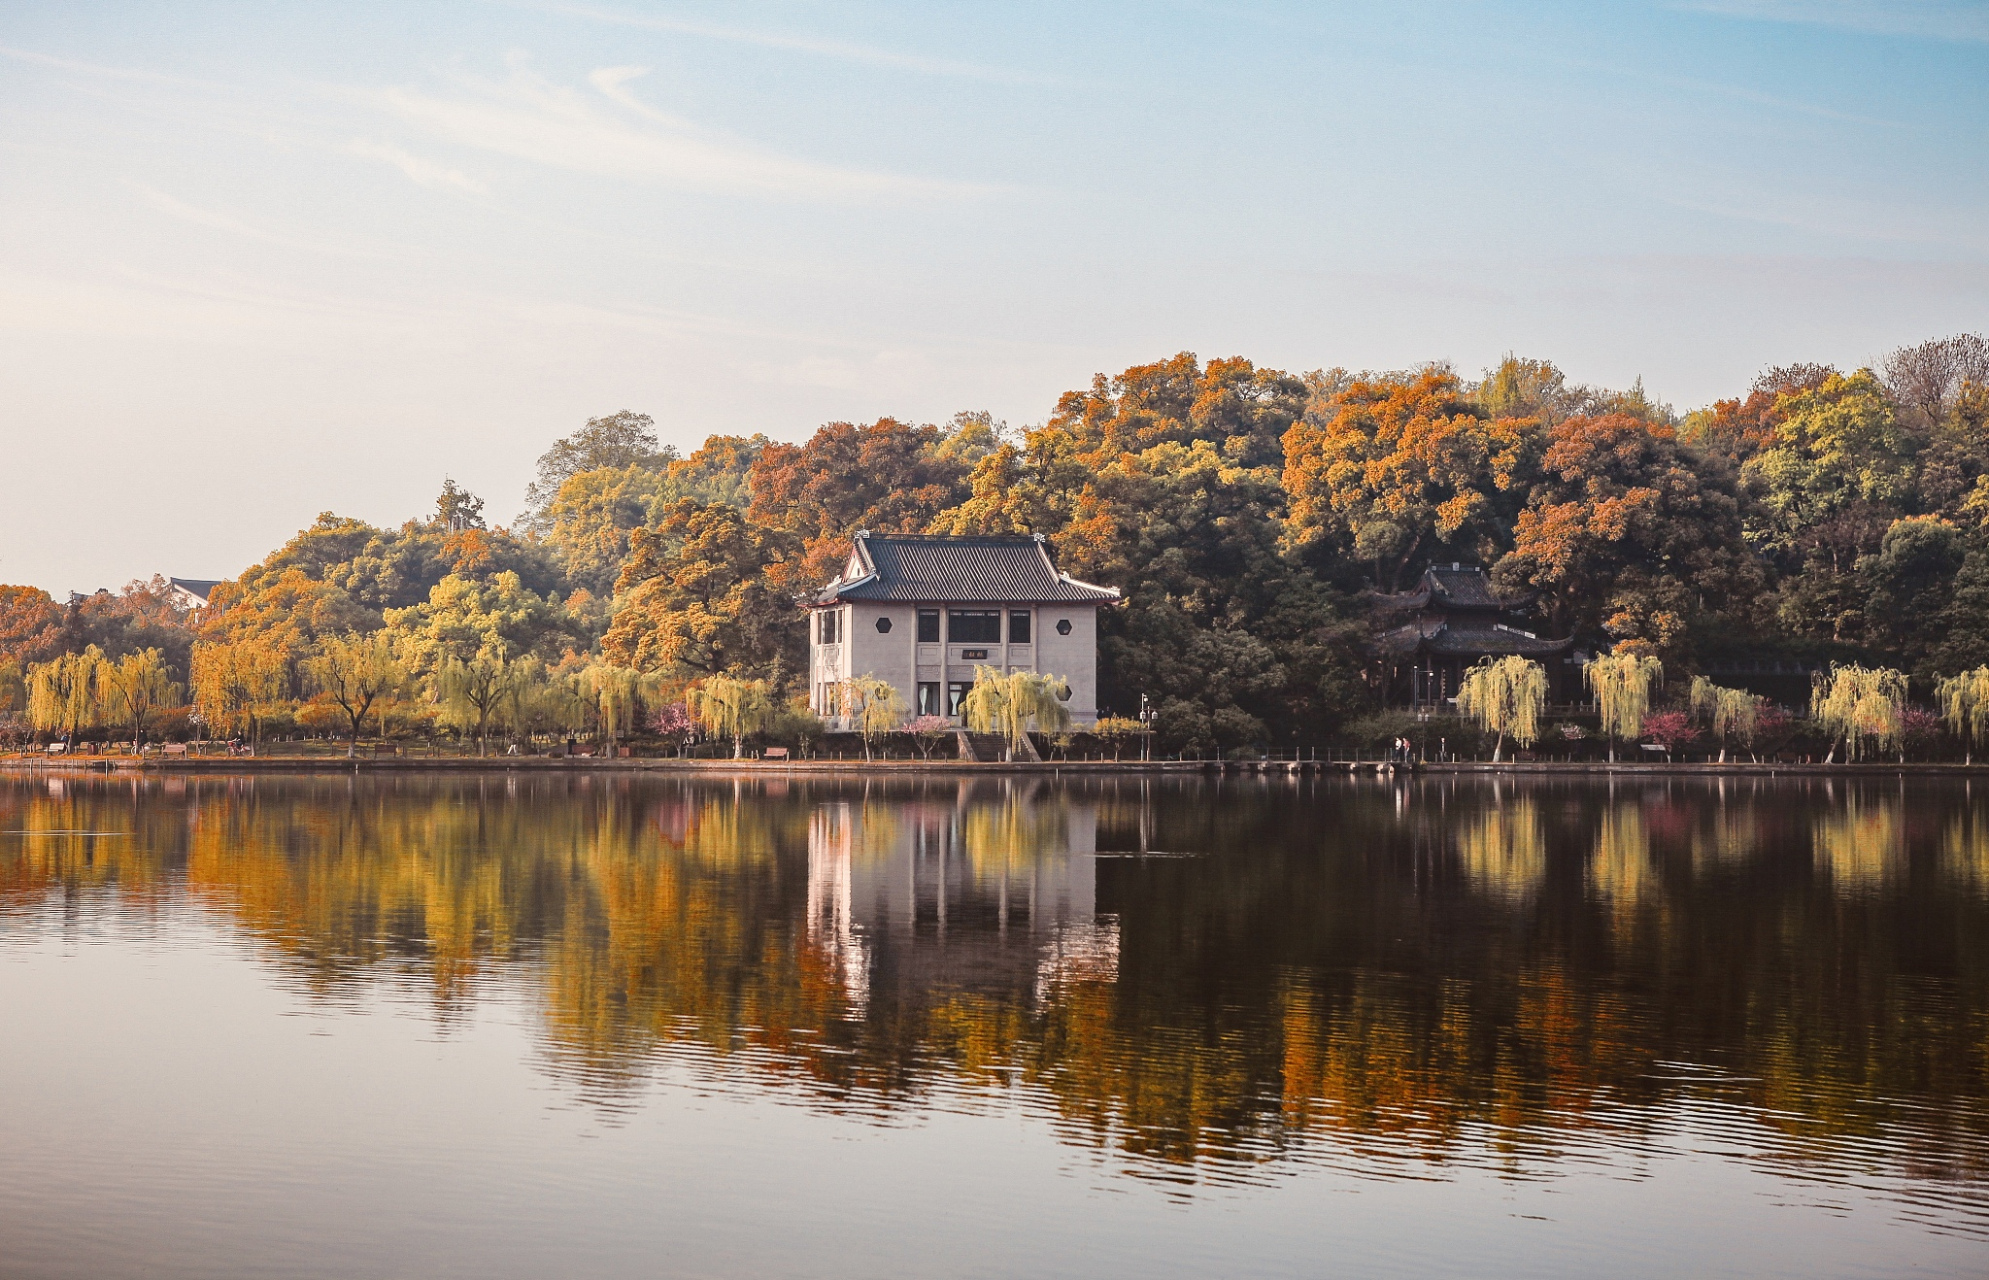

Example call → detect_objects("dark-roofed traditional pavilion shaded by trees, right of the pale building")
1374 562 1579 710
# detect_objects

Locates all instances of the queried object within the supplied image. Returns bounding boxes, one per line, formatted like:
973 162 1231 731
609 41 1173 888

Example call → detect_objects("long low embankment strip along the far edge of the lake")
0 755 1989 779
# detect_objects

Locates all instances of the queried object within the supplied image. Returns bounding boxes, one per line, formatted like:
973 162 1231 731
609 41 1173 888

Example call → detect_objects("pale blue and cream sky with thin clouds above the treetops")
0 0 1989 598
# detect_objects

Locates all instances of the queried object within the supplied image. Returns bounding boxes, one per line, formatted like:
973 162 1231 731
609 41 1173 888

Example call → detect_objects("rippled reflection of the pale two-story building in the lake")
808 783 1118 1014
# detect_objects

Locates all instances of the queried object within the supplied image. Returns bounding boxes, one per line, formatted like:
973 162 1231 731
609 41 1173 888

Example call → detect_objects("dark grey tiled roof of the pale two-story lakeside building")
814 533 1120 604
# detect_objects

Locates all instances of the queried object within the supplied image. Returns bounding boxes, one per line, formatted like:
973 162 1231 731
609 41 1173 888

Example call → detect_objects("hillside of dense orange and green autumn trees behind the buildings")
0 336 1989 749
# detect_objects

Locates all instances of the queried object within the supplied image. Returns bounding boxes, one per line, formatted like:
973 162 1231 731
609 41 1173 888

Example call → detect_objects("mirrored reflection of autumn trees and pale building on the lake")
0 777 1989 1230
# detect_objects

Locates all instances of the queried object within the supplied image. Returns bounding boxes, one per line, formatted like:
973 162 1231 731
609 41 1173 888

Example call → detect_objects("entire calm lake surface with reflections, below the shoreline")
0 775 1989 1280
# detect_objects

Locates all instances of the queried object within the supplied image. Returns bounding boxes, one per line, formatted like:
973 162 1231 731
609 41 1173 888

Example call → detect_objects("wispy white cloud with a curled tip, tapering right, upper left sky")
358 66 993 203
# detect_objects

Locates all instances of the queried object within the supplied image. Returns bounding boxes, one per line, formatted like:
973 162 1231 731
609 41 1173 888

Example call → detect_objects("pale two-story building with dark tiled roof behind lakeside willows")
808 533 1120 723
